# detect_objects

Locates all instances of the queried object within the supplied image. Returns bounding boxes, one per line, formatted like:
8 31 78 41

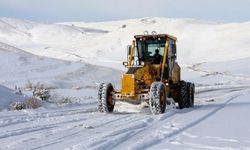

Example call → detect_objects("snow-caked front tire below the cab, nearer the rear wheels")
149 82 167 115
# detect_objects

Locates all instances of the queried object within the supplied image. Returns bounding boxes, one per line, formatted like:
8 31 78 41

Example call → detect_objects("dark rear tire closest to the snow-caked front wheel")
178 81 189 109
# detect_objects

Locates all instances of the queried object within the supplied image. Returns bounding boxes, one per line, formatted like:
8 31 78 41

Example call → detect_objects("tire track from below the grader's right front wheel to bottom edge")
74 112 175 150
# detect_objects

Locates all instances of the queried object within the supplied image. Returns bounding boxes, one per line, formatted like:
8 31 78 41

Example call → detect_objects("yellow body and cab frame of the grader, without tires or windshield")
114 34 180 102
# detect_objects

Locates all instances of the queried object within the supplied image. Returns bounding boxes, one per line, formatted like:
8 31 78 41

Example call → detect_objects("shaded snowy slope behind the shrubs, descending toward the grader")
0 42 121 88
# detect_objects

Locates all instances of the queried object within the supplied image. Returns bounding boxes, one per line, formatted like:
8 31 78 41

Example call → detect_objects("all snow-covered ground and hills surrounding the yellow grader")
0 18 250 150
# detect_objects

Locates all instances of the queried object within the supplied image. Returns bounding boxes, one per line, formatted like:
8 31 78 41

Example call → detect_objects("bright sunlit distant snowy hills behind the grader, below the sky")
0 18 250 69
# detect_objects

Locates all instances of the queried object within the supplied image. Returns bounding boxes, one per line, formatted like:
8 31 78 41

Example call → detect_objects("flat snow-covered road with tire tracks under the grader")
0 77 250 150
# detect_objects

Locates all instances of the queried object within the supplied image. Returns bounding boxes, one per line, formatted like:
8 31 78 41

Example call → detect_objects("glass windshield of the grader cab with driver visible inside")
137 39 166 64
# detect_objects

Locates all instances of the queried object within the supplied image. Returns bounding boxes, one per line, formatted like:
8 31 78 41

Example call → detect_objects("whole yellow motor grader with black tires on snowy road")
98 32 195 114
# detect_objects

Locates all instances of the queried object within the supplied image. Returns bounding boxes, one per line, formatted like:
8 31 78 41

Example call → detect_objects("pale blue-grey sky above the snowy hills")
0 0 250 22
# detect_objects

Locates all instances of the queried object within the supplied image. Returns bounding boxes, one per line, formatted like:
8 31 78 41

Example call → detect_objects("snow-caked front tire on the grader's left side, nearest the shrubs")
98 83 115 113
